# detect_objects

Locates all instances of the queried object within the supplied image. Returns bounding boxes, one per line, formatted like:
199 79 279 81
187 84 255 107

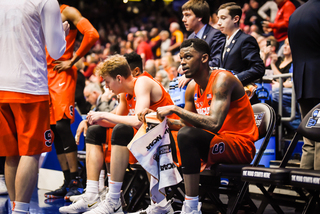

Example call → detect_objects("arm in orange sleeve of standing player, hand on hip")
54 7 99 72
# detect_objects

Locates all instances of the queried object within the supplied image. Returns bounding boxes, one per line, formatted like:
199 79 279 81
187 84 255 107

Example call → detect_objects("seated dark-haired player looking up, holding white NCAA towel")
139 39 259 214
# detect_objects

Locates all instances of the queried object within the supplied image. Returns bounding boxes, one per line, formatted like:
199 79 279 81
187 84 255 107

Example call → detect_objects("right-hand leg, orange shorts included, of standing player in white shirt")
11 101 52 214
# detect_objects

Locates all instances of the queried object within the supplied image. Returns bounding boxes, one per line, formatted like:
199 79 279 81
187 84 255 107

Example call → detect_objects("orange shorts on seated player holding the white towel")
201 134 256 170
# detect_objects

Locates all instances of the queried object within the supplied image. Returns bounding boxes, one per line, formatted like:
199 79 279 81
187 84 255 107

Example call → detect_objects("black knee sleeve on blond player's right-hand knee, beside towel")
111 124 134 146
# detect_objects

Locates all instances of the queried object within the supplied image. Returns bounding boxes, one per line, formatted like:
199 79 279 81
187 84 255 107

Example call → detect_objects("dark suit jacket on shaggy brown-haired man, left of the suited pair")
188 24 226 67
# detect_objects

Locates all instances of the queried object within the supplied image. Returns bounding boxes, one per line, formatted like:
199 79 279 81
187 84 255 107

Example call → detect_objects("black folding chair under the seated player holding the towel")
199 103 276 213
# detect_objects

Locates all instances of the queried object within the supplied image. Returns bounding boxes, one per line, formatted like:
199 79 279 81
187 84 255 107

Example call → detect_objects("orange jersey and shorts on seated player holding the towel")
194 70 259 170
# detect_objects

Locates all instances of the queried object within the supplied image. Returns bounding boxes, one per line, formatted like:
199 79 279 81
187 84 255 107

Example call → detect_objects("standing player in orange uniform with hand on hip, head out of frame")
45 5 99 200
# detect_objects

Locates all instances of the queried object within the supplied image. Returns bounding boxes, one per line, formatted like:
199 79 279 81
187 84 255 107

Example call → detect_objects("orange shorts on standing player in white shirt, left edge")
0 101 52 156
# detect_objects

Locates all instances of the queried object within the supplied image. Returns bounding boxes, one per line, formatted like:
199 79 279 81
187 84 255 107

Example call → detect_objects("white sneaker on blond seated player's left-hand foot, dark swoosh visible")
59 196 100 213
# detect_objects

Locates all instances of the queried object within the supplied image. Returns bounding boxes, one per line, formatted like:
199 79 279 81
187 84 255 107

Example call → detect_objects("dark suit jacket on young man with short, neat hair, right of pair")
219 30 265 85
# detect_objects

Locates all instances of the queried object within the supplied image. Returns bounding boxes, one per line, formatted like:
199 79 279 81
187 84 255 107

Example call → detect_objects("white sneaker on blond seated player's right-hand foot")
84 194 124 214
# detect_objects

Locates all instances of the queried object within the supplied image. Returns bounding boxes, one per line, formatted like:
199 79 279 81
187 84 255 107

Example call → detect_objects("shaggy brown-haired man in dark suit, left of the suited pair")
182 0 225 67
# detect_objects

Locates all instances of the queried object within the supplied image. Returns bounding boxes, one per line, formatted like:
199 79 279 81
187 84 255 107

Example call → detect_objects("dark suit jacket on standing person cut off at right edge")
288 0 320 100
